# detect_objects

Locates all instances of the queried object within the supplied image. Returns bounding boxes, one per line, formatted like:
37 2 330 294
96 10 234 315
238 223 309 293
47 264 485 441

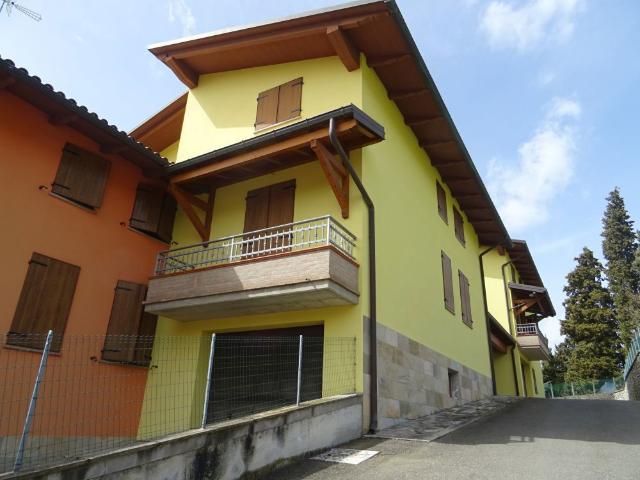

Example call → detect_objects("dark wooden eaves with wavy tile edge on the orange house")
0 57 168 174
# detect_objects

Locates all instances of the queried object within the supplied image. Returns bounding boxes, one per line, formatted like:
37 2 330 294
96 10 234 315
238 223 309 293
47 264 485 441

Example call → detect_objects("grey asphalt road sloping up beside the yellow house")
264 399 640 480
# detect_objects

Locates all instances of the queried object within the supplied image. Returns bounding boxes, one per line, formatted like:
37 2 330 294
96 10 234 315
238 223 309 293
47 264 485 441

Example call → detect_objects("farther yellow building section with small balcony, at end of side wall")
483 240 555 397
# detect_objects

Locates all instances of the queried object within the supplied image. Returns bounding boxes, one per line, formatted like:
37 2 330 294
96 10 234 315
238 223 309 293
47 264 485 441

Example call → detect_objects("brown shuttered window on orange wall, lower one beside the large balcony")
102 280 157 365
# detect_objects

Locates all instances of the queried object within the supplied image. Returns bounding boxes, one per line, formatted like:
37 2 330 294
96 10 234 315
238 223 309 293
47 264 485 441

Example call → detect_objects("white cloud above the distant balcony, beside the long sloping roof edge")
488 98 581 233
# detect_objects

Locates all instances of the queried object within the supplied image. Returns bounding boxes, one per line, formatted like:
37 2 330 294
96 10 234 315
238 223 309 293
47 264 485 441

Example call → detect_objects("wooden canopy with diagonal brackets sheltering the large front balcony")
166 105 384 241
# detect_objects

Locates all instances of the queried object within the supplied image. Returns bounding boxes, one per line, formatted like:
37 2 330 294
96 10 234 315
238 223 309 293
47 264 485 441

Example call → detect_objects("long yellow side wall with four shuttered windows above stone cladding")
361 59 491 376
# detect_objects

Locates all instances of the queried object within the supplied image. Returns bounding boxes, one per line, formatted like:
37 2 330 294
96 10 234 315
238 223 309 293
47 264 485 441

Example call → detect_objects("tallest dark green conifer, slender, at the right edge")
602 187 640 348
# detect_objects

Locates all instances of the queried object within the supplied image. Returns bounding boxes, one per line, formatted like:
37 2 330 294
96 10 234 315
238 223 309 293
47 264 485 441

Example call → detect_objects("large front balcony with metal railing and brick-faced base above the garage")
145 216 359 321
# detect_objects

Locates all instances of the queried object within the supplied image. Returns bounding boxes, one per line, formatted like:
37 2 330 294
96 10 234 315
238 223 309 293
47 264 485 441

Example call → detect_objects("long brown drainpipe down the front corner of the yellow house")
329 118 378 432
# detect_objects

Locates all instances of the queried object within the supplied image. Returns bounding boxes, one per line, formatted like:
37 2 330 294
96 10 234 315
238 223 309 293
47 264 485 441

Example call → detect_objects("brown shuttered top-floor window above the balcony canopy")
254 77 303 130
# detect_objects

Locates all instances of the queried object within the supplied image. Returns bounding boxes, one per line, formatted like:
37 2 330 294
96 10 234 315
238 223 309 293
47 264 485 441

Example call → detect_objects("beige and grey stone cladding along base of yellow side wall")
377 324 492 429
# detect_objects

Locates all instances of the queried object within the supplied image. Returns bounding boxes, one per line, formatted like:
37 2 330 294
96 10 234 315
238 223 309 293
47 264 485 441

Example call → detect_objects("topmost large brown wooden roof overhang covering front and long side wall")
150 0 510 246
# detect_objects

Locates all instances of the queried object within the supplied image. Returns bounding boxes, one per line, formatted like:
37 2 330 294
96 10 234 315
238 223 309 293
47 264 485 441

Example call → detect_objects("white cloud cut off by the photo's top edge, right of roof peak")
480 0 584 51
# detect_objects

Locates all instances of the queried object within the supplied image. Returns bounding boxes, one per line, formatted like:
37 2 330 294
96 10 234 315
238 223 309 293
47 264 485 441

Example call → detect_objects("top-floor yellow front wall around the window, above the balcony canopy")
177 57 362 161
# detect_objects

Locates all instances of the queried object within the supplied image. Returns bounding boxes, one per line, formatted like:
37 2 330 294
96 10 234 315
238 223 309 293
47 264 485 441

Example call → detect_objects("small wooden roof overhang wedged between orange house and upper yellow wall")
129 92 188 152
